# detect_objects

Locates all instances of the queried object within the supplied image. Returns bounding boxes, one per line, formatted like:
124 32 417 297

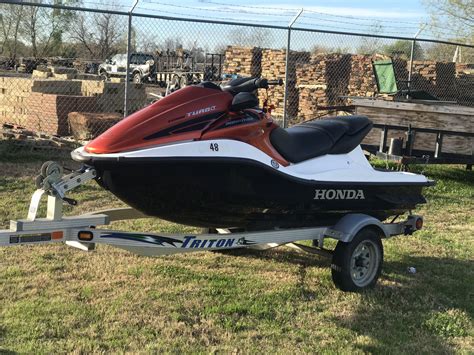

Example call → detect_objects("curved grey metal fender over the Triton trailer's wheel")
331 213 390 243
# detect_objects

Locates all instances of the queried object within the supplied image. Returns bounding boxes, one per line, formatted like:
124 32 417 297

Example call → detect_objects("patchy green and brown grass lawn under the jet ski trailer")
0 152 474 353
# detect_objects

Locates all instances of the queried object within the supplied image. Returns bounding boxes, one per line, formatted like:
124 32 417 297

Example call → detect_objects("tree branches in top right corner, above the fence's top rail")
424 0 474 44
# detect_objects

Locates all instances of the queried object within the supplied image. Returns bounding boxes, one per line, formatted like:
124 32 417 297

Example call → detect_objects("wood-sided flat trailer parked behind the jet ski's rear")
353 98 474 170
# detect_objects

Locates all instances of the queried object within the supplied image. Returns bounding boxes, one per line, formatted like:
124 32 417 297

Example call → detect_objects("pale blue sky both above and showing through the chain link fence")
76 0 464 51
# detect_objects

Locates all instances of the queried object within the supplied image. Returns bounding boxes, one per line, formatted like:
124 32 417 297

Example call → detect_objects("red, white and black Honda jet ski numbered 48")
72 78 433 230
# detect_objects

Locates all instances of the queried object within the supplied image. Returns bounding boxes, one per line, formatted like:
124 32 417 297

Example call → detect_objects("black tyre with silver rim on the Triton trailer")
331 228 383 292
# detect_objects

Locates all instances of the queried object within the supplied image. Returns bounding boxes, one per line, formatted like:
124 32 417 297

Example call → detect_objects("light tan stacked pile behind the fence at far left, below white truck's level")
0 76 146 135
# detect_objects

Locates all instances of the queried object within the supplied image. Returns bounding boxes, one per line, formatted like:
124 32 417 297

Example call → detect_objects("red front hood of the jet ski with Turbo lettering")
85 86 232 154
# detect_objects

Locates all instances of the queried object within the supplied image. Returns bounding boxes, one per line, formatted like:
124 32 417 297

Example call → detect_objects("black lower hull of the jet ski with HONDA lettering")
87 157 428 229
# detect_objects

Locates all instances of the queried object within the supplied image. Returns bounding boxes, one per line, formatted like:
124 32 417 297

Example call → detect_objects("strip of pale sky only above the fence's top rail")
85 0 432 37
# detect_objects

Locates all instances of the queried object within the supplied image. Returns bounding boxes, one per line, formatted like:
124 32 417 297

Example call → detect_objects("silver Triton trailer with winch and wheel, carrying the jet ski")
0 162 423 291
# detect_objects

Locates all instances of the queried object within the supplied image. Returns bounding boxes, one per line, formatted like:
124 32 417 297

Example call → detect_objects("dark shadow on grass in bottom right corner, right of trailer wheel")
334 256 474 354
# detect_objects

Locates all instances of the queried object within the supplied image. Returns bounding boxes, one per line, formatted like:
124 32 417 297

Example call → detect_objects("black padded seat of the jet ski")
270 116 372 163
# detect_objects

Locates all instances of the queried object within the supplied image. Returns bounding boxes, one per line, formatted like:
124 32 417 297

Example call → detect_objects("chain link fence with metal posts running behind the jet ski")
0 2 474 156
